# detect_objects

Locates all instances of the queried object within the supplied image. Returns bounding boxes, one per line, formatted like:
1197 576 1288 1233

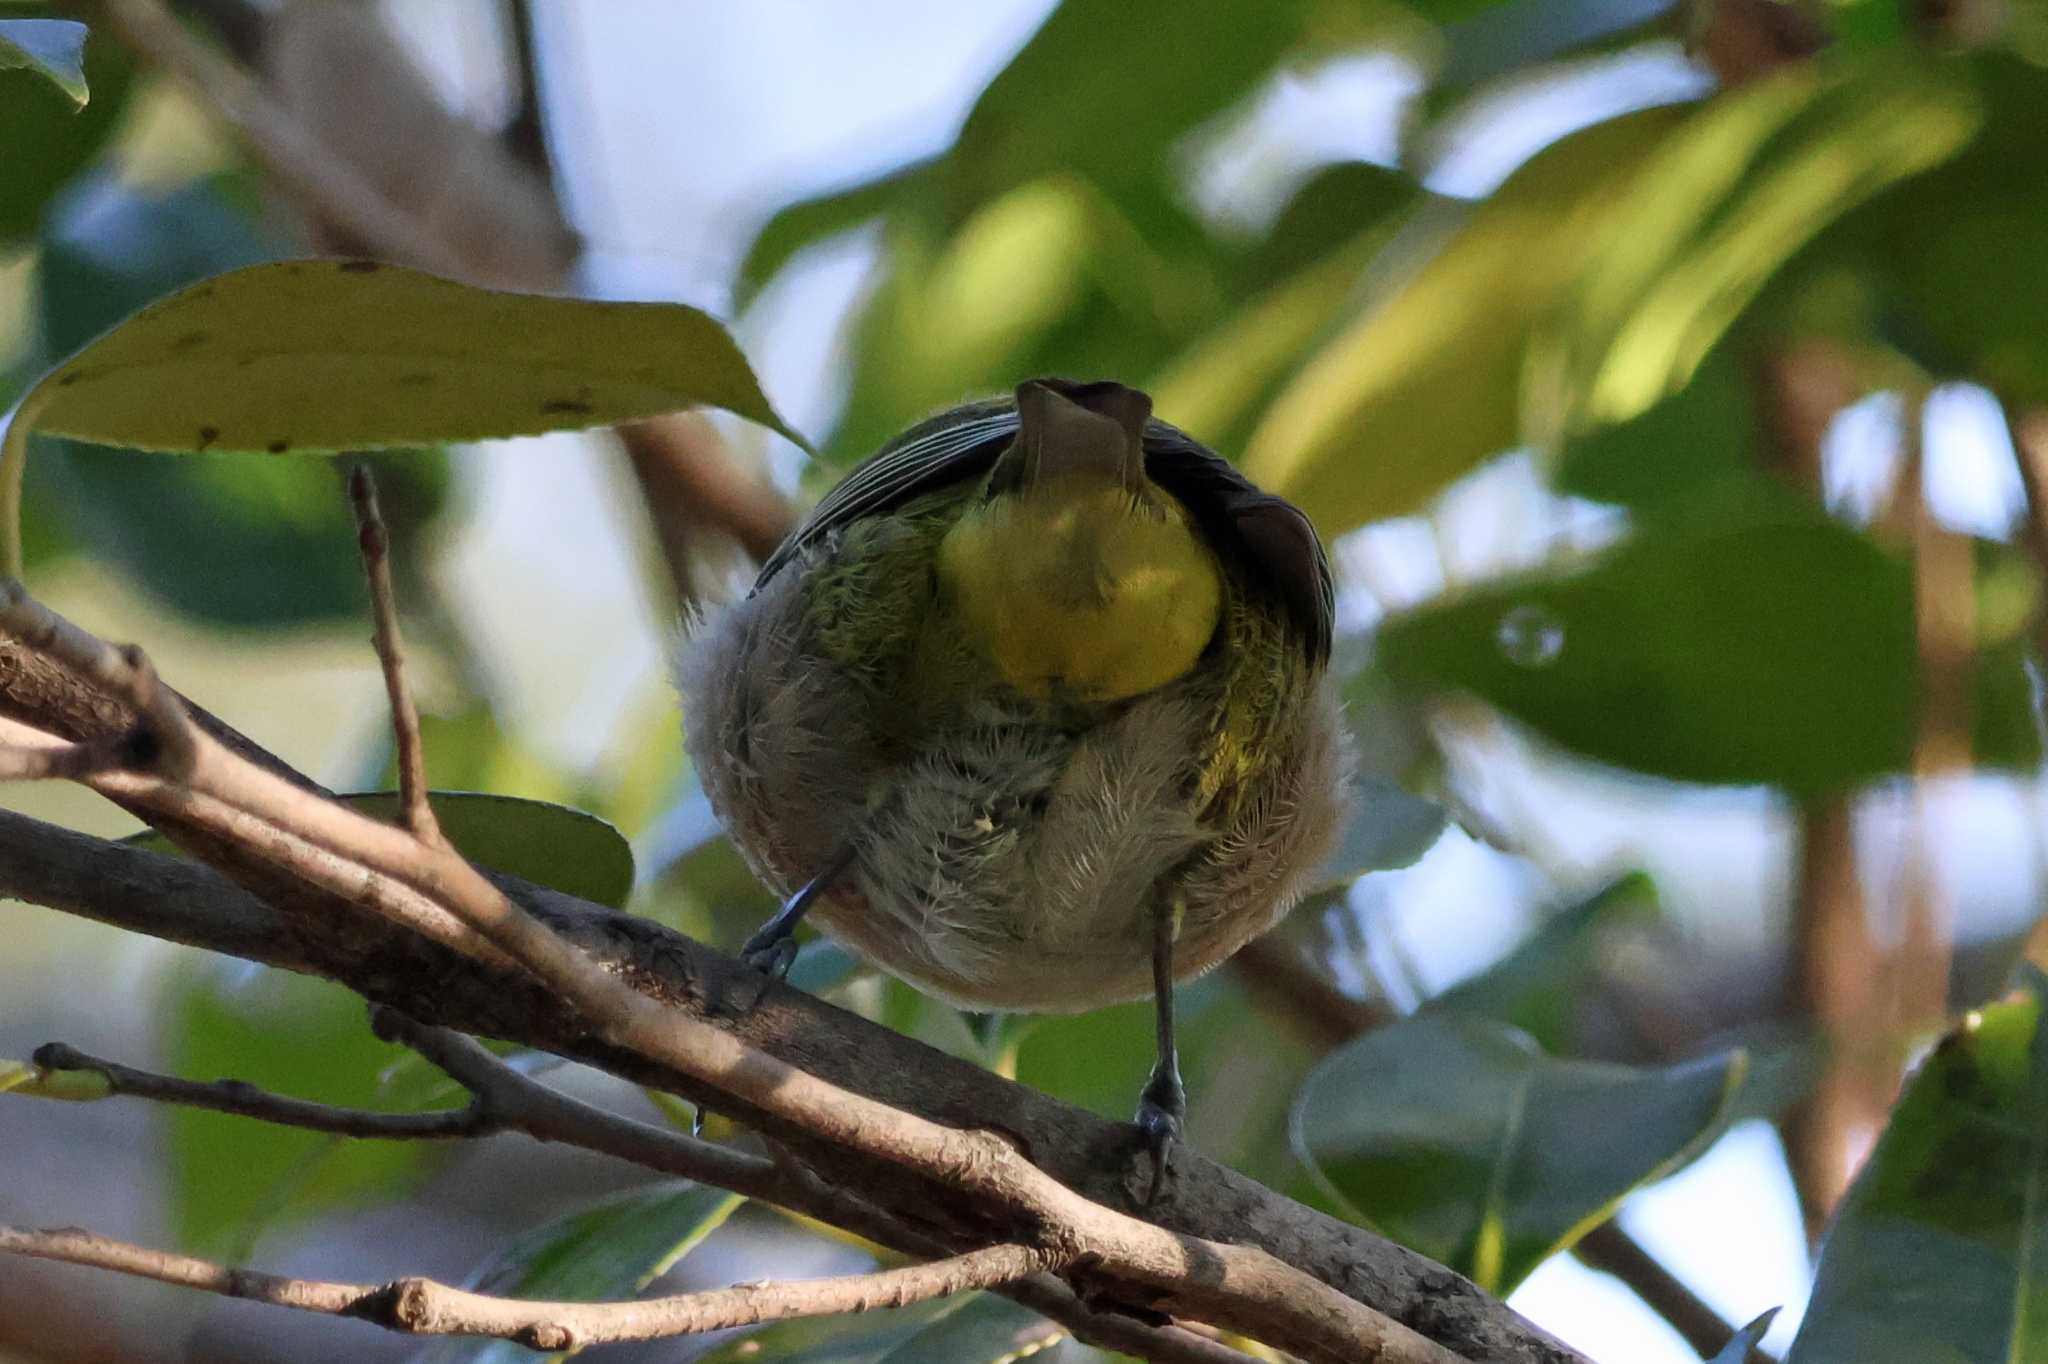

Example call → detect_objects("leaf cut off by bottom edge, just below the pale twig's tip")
705 1292 1065 1364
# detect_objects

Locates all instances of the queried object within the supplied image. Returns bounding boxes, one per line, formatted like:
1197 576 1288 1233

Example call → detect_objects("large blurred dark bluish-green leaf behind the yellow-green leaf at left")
27 176 446 627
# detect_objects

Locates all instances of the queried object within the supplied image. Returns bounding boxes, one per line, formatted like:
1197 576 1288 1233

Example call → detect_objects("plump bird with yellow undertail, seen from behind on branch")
676 377 1350 1196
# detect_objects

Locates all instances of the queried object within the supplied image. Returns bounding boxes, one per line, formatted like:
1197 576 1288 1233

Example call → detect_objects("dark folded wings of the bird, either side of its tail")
754 387 1337 664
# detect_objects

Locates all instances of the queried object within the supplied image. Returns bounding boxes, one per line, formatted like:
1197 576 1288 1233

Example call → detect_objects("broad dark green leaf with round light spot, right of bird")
1380 485 2040 795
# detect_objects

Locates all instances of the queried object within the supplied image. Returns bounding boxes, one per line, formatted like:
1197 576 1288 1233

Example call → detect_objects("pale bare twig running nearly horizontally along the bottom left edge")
0 1227 1055 1350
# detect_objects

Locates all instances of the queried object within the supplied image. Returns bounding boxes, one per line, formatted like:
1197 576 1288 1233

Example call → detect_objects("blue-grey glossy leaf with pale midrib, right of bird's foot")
1292 1012 1747 1294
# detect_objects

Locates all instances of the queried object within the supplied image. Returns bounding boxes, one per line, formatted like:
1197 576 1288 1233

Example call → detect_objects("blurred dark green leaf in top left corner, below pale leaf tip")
0 4 133 246
